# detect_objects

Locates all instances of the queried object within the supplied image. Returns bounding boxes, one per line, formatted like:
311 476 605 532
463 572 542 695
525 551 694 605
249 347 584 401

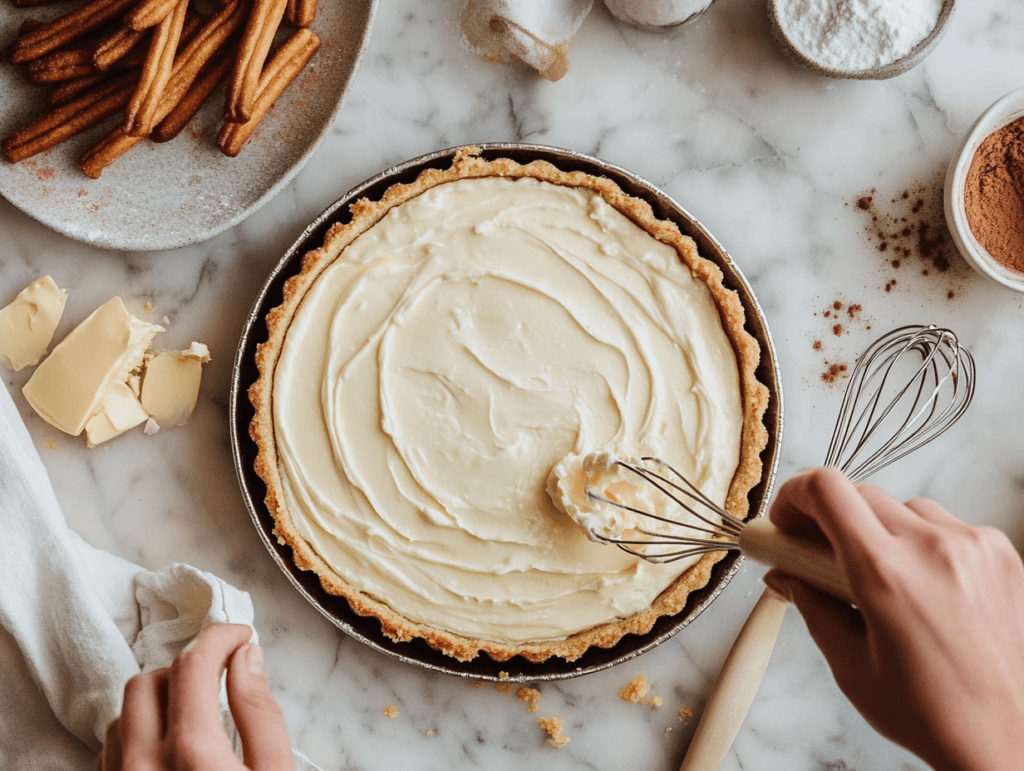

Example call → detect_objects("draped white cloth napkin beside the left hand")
0 388 316 771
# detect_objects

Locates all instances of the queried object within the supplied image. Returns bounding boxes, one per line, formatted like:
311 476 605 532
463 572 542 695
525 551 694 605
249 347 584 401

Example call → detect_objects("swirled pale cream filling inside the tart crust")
273 177 742 644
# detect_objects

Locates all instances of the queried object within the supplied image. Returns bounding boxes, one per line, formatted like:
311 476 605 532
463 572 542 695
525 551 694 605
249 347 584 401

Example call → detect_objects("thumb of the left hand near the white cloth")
227 643 295 771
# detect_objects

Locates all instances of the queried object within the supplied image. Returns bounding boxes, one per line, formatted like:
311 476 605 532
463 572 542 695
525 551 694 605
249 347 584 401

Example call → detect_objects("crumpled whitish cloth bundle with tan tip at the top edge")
462 0 594 80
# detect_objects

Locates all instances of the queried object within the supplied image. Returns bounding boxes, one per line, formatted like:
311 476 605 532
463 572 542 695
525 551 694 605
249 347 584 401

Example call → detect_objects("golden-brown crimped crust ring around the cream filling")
249 146 769 661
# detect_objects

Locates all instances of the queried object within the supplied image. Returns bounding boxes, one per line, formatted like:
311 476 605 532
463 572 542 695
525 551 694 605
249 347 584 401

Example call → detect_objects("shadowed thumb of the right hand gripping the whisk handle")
764 570 868 694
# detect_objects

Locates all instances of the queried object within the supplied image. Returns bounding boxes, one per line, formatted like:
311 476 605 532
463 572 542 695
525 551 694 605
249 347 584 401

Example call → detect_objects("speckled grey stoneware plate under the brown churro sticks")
0 0 377 251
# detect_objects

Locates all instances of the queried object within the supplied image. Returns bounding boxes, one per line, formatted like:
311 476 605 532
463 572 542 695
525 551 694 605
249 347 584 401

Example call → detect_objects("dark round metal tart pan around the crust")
229 143 782 682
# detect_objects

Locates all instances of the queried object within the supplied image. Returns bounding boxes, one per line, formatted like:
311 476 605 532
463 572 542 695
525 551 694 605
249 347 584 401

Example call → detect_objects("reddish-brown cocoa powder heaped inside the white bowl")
964 118 1024 273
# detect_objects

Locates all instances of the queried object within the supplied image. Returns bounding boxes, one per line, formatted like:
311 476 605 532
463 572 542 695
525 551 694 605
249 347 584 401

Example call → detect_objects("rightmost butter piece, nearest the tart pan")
142 342 210 428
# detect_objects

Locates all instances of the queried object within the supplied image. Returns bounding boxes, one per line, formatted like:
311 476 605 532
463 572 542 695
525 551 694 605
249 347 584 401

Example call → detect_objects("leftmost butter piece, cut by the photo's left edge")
0 275 68 372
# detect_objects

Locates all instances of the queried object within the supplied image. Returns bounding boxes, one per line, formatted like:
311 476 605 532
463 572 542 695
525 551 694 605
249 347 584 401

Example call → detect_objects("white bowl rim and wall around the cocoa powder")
943 88 1024 292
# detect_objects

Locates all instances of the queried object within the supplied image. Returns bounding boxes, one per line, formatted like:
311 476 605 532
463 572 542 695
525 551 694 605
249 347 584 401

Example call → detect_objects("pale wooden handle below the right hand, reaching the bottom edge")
679 590 786 771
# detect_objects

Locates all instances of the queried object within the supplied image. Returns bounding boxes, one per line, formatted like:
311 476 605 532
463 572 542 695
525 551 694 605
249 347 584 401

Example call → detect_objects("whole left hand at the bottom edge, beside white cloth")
96 624 295 771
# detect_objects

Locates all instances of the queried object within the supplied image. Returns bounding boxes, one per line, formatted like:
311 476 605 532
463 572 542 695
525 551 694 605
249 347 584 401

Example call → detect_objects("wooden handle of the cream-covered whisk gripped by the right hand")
739 519 853 604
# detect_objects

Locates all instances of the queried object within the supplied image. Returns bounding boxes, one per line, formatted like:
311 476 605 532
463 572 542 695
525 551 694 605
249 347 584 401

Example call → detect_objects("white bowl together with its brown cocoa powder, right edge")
944 88 1024 292
